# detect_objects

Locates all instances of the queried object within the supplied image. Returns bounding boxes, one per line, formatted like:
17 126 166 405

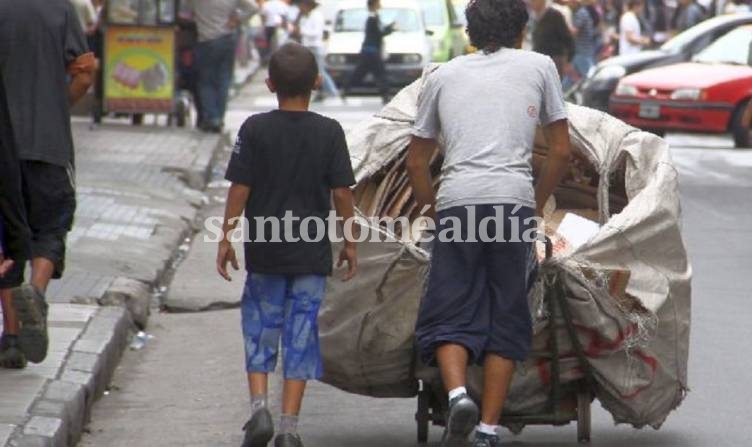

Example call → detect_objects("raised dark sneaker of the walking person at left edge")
12 284 49 363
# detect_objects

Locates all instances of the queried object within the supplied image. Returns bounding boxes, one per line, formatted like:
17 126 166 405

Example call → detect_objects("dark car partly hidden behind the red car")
577 13 752 111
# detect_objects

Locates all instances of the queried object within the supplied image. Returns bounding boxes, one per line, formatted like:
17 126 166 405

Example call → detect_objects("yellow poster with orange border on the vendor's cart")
104 26 175 113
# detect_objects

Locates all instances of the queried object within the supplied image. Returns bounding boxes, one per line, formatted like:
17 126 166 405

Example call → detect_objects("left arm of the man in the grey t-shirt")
405 136 436 222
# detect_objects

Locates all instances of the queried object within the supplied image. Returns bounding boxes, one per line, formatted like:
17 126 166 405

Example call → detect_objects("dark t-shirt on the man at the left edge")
0 0 88 167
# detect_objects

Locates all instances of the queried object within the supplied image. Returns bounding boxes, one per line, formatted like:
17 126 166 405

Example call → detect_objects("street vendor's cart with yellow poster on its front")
95 0 191 127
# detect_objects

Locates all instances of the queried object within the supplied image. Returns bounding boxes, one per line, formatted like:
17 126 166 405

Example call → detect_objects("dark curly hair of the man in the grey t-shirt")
465 0 529 53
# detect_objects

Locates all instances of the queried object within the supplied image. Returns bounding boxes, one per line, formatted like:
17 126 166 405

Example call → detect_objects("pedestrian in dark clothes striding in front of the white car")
343 0 396 103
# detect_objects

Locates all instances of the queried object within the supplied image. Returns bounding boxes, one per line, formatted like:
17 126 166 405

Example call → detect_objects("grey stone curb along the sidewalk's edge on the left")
0 124 229 447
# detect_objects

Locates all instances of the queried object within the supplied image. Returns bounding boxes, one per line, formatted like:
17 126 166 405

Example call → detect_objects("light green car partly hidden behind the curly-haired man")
419 0 467 62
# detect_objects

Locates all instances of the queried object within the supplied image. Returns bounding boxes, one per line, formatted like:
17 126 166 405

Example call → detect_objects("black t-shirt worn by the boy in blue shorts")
226 110 355 275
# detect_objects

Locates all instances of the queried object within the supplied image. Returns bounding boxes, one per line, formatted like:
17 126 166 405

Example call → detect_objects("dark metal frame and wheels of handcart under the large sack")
415 238 594 444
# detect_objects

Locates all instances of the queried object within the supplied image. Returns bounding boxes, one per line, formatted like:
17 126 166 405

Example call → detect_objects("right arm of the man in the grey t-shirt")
535 120 571 217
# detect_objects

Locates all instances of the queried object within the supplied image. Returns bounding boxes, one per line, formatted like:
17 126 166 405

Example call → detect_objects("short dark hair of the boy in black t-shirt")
269 43 319 98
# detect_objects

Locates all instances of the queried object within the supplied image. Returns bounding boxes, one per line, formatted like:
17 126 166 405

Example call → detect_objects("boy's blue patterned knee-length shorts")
241 273 326 380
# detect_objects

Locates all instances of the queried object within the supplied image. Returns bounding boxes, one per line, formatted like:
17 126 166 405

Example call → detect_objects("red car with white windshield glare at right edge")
609 25 752 147
